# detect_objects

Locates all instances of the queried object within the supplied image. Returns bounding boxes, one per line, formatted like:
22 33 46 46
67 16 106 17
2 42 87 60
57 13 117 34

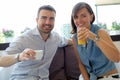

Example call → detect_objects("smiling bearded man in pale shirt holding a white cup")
5 5 72 80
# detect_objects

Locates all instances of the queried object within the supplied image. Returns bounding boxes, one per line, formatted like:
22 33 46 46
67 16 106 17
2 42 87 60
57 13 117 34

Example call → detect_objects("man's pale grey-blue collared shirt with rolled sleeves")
5 27 68 80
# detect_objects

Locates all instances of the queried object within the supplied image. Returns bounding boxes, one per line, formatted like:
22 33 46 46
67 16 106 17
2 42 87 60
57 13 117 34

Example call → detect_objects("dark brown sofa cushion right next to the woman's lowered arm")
64 46 81 80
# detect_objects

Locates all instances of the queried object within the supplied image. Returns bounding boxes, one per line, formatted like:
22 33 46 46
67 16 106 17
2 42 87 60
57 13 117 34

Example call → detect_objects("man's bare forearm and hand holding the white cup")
0 49 36 67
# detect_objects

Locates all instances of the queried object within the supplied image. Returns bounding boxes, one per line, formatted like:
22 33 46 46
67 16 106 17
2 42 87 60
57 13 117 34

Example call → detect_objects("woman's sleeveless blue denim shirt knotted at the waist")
75 25 115 80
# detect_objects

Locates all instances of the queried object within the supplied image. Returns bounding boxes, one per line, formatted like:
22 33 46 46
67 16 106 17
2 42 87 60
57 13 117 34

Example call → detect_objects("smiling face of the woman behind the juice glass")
73 8 93 29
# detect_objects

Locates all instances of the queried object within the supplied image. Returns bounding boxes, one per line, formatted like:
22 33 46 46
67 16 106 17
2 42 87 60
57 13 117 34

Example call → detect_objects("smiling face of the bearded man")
36 10 56 34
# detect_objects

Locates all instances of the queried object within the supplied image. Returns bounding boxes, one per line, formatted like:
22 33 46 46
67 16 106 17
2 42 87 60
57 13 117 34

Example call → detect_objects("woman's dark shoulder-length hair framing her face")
71 2 95 34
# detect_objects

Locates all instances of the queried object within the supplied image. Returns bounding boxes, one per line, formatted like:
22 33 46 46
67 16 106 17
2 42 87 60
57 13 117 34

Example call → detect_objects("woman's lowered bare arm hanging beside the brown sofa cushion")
72 38 89 80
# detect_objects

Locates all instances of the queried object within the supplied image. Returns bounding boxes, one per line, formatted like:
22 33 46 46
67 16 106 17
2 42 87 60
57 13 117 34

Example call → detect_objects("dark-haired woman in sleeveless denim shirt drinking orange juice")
71 2 120 80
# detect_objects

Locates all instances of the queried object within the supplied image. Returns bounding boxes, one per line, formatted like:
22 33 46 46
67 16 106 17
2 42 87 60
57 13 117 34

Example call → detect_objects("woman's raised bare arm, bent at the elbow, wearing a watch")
87 29 120 62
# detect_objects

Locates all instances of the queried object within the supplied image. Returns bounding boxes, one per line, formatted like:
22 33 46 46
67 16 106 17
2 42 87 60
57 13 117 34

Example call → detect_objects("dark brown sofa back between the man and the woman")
49 46 81 80
